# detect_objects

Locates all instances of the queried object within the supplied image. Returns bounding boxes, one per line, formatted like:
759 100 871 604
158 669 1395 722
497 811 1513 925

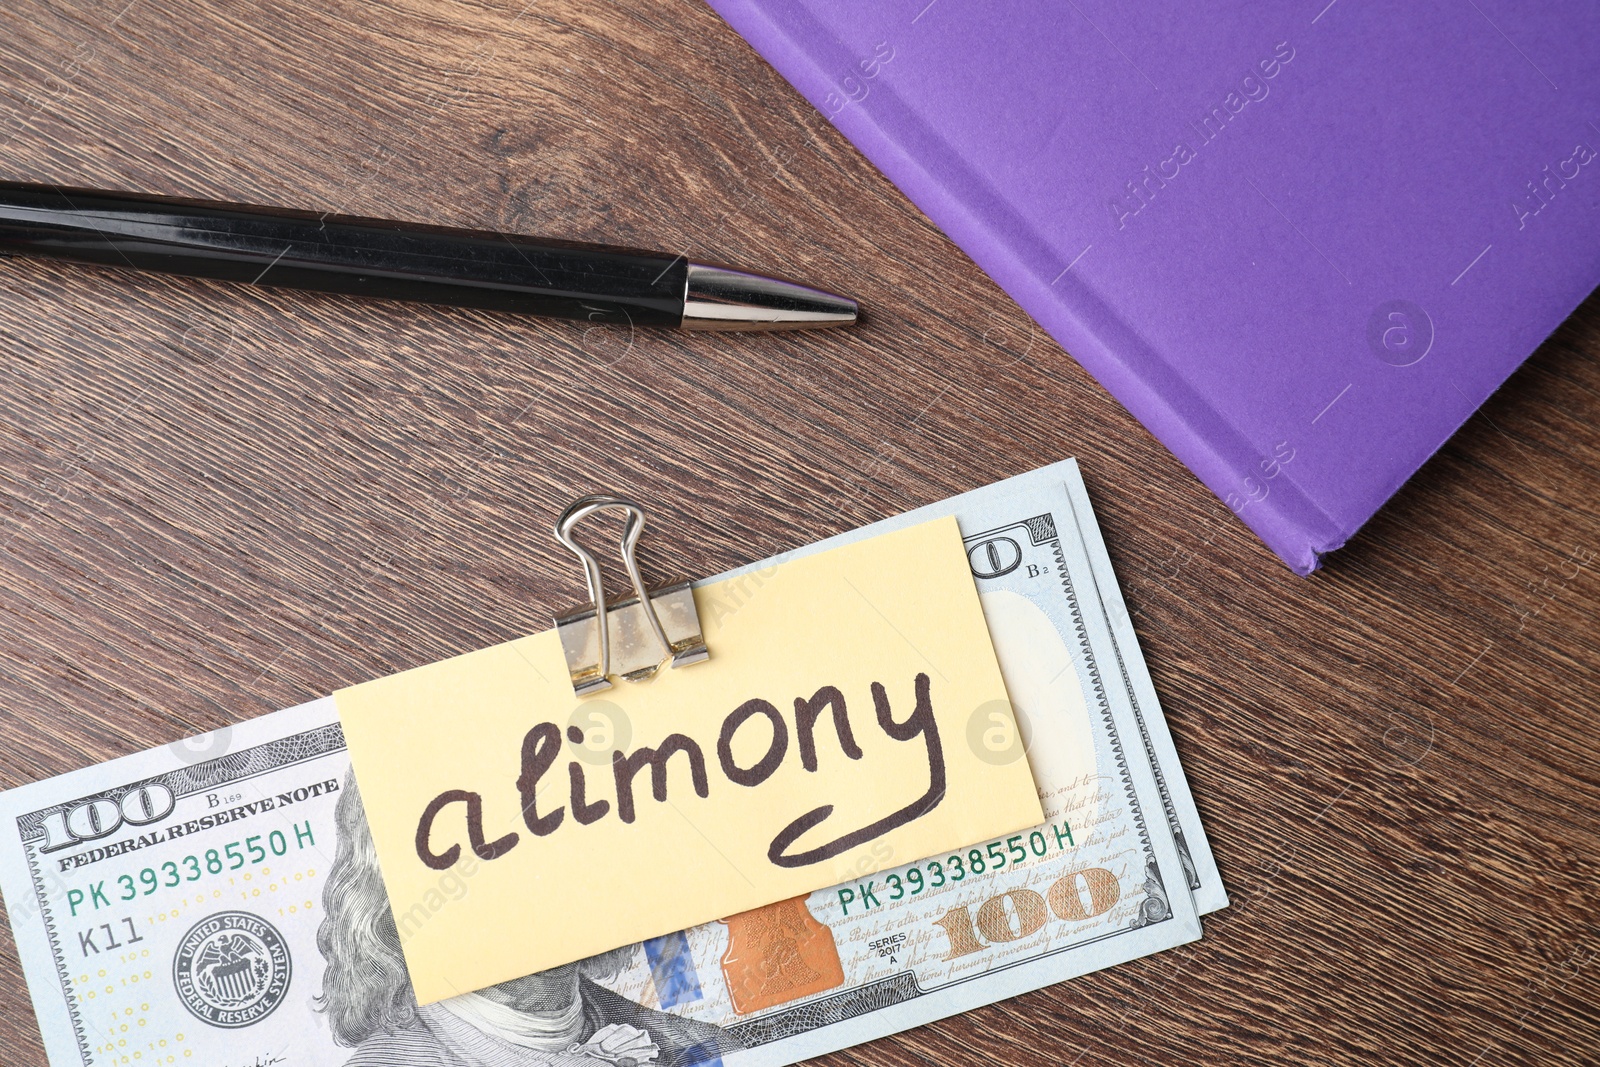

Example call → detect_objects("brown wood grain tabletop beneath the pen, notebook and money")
0 0 1600 1065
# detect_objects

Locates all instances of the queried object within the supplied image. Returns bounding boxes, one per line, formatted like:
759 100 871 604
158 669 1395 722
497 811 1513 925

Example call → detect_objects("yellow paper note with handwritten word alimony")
334 518 1043 1003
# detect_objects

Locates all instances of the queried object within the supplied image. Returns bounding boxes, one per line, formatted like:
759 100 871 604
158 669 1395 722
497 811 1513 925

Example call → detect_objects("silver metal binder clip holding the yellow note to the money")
555 496 710 696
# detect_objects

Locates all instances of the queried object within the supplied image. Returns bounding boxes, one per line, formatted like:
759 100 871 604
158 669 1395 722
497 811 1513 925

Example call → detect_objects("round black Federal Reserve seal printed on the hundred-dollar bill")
173 912 291 1030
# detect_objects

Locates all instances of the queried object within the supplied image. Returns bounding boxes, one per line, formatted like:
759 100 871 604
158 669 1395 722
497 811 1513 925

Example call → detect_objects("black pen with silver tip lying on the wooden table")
0 182 856 330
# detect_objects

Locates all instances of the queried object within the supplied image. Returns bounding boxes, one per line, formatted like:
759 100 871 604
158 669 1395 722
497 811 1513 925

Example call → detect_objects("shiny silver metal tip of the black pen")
683 262 859 330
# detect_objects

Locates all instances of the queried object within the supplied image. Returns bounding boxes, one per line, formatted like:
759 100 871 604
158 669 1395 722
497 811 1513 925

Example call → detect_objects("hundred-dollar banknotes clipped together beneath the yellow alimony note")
0 461 1227 1067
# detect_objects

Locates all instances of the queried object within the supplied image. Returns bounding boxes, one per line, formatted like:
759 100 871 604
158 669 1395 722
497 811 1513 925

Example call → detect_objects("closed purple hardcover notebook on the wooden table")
710 0 1600 573
